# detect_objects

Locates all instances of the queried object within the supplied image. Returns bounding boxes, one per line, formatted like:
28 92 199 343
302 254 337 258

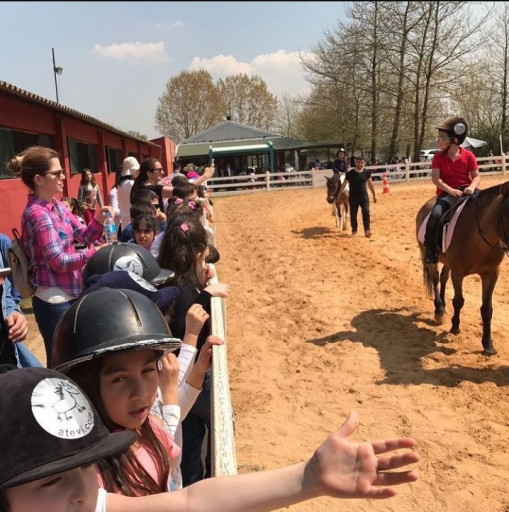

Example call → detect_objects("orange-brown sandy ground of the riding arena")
25 177 509 512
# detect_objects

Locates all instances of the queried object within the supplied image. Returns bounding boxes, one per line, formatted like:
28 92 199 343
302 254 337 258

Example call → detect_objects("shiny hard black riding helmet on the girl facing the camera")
51 288 182 373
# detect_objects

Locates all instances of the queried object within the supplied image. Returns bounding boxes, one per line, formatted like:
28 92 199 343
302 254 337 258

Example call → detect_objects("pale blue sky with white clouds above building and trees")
0 1 348 138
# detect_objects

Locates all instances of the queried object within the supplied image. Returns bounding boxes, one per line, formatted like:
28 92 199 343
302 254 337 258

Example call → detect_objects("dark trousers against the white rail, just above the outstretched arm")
180 370 212 487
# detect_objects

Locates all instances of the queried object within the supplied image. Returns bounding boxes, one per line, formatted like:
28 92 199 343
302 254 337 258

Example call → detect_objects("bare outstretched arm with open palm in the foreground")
107 412 419 512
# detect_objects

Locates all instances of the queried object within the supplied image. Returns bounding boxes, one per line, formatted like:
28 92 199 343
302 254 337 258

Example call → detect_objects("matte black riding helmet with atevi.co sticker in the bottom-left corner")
0 365 136 489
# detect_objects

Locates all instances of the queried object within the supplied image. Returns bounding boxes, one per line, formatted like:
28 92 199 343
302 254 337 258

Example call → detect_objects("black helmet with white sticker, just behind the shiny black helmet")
83 242 175 288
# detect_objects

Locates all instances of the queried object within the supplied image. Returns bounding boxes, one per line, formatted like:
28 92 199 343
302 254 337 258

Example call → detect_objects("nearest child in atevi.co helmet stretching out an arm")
0 368 419 512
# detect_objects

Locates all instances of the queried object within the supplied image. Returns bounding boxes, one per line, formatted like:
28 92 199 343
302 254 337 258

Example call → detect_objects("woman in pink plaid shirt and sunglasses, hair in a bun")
7 146 109 366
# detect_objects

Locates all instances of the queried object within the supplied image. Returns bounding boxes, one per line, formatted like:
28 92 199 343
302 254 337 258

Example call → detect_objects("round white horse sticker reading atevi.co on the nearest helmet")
31 378 94 439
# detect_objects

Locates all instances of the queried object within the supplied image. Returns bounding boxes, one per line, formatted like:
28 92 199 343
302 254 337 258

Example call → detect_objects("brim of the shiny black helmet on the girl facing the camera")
54 335 182 374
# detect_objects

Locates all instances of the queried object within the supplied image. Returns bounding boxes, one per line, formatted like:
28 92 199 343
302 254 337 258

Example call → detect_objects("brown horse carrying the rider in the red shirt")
416 181 509 355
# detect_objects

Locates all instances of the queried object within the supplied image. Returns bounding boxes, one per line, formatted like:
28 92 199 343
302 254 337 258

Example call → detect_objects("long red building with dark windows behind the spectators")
0 81 175 234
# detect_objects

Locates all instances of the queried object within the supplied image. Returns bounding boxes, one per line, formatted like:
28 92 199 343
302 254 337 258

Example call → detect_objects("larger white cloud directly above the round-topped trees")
189 50 311 96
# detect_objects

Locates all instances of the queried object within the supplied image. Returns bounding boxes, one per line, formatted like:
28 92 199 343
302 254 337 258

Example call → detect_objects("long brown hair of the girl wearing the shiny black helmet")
69 357 170 496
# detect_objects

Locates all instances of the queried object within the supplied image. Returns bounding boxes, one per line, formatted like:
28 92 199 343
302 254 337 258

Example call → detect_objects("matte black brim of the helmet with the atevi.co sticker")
0 430 136 488
